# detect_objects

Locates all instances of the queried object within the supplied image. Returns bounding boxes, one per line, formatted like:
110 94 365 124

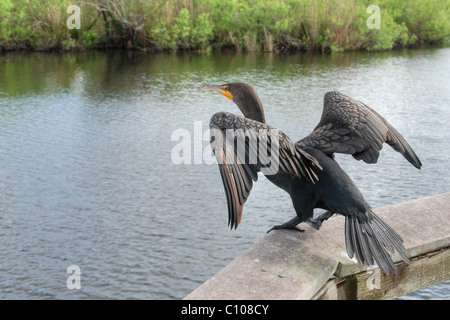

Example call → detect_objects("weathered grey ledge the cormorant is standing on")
185 192 450 300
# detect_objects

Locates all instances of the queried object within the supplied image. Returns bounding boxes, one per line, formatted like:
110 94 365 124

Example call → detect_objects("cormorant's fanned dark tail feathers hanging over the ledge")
345 211 409 274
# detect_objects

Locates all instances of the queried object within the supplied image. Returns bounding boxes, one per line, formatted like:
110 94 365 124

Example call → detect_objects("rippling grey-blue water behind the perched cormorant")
0 48 450 299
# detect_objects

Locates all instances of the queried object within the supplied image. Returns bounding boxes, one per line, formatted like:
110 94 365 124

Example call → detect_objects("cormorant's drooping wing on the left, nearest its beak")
210 112 322 228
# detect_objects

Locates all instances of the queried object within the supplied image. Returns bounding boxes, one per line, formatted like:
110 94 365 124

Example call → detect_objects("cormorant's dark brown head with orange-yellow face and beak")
202 82 265 123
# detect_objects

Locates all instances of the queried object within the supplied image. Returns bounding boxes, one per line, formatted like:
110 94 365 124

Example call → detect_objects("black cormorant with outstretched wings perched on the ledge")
202 83 422 274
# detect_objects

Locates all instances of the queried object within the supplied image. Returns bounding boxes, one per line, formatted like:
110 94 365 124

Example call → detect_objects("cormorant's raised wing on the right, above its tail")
297 91 422 169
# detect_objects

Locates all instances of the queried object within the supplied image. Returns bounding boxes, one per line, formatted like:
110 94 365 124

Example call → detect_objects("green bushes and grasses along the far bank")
0 0 450 52
